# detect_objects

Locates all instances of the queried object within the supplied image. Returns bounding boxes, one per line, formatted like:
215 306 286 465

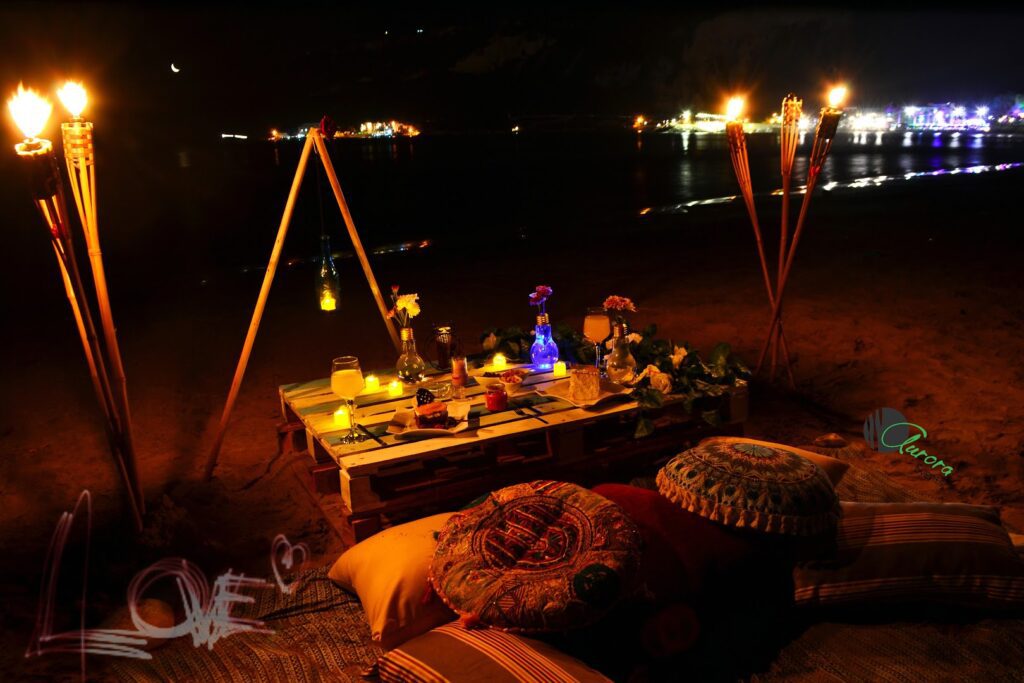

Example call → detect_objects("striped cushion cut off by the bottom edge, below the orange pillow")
380 623 608 683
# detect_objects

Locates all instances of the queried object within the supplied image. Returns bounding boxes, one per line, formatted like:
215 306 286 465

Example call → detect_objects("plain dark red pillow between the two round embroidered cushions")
594 483 757 602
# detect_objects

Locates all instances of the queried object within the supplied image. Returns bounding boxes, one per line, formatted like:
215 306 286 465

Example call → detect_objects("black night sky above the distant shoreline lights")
0 2 1024 138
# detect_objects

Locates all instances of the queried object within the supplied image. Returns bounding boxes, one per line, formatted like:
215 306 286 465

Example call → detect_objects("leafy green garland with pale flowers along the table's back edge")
480 325 751 438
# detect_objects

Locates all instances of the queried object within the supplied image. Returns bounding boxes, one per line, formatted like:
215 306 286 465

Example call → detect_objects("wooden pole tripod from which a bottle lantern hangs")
206 127 401 479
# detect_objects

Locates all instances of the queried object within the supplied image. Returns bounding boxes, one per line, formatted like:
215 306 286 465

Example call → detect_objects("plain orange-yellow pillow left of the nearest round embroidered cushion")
328 512 457 650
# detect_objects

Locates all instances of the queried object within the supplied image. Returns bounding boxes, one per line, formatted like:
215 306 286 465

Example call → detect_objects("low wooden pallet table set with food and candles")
279 371 746 541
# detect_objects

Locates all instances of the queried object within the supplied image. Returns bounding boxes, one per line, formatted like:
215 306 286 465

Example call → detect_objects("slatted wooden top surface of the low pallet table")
281 365 655 473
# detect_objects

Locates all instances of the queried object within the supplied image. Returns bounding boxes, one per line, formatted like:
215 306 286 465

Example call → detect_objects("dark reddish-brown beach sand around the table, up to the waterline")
0 171 1024 680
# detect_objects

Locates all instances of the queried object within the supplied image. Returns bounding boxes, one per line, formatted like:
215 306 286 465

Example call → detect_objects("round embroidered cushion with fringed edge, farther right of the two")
657 441 840 536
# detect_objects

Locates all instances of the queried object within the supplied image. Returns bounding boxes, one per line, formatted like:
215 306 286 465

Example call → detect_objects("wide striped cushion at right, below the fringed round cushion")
794 502 1024 609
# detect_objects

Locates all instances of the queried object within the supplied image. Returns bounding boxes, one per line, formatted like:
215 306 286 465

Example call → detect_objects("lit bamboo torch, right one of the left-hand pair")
57 83 145 514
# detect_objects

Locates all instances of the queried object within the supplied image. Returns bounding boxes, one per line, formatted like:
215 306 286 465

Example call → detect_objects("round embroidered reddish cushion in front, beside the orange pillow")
430 481 640 632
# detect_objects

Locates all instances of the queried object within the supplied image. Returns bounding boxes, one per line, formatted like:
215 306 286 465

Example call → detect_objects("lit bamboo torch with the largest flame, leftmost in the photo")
7 84 142 528
